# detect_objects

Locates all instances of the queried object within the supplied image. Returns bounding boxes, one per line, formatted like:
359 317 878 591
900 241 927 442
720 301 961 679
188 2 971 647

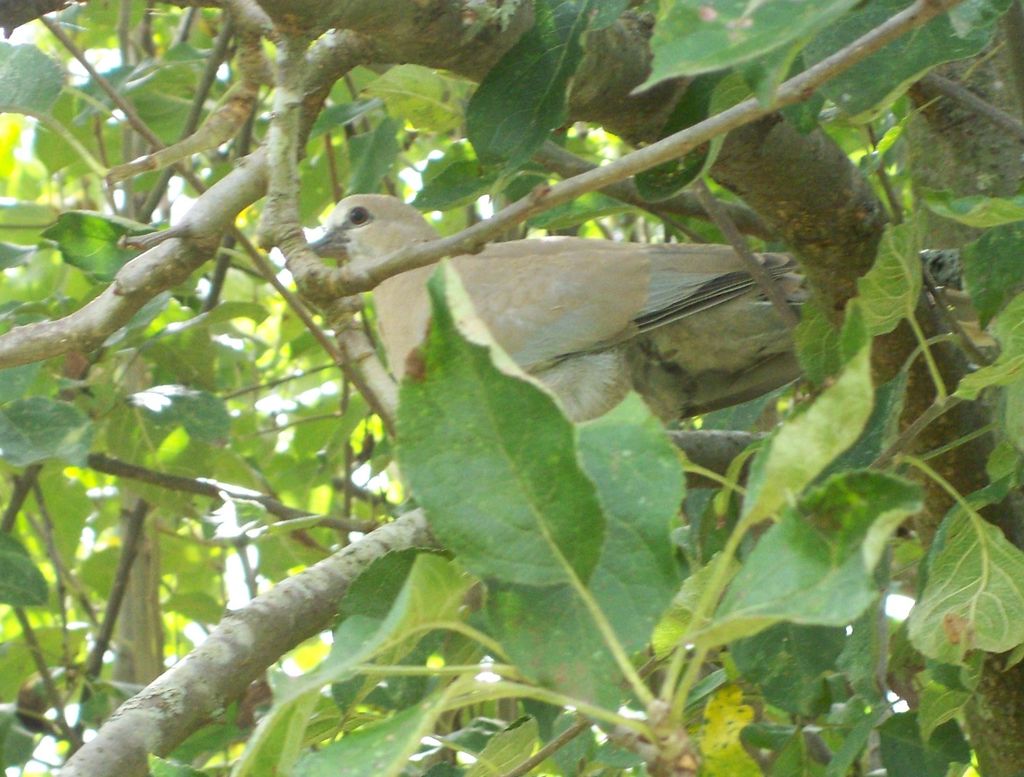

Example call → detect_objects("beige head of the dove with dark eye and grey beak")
310 195 437 266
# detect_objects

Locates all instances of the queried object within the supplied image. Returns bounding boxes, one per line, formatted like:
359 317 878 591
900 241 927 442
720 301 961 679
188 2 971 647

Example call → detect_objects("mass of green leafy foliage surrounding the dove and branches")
0 0 1024 777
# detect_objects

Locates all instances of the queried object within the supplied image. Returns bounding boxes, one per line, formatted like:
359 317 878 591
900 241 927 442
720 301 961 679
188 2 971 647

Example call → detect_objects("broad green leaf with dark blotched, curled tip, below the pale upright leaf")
696 471 922 643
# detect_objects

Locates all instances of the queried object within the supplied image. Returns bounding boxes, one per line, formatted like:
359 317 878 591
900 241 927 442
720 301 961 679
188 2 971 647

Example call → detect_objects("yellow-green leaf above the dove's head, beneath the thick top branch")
364 64 470 132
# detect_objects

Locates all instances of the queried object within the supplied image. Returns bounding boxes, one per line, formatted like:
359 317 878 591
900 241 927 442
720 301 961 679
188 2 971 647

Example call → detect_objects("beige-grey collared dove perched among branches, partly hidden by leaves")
312 195 804 421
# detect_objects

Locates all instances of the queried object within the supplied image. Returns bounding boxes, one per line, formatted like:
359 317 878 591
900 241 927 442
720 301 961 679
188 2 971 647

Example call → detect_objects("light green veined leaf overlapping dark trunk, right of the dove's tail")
857 221 922 336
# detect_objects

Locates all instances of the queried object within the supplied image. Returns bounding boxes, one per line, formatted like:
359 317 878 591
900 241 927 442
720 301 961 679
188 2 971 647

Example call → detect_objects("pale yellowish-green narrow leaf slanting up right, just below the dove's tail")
743 346 874 521
